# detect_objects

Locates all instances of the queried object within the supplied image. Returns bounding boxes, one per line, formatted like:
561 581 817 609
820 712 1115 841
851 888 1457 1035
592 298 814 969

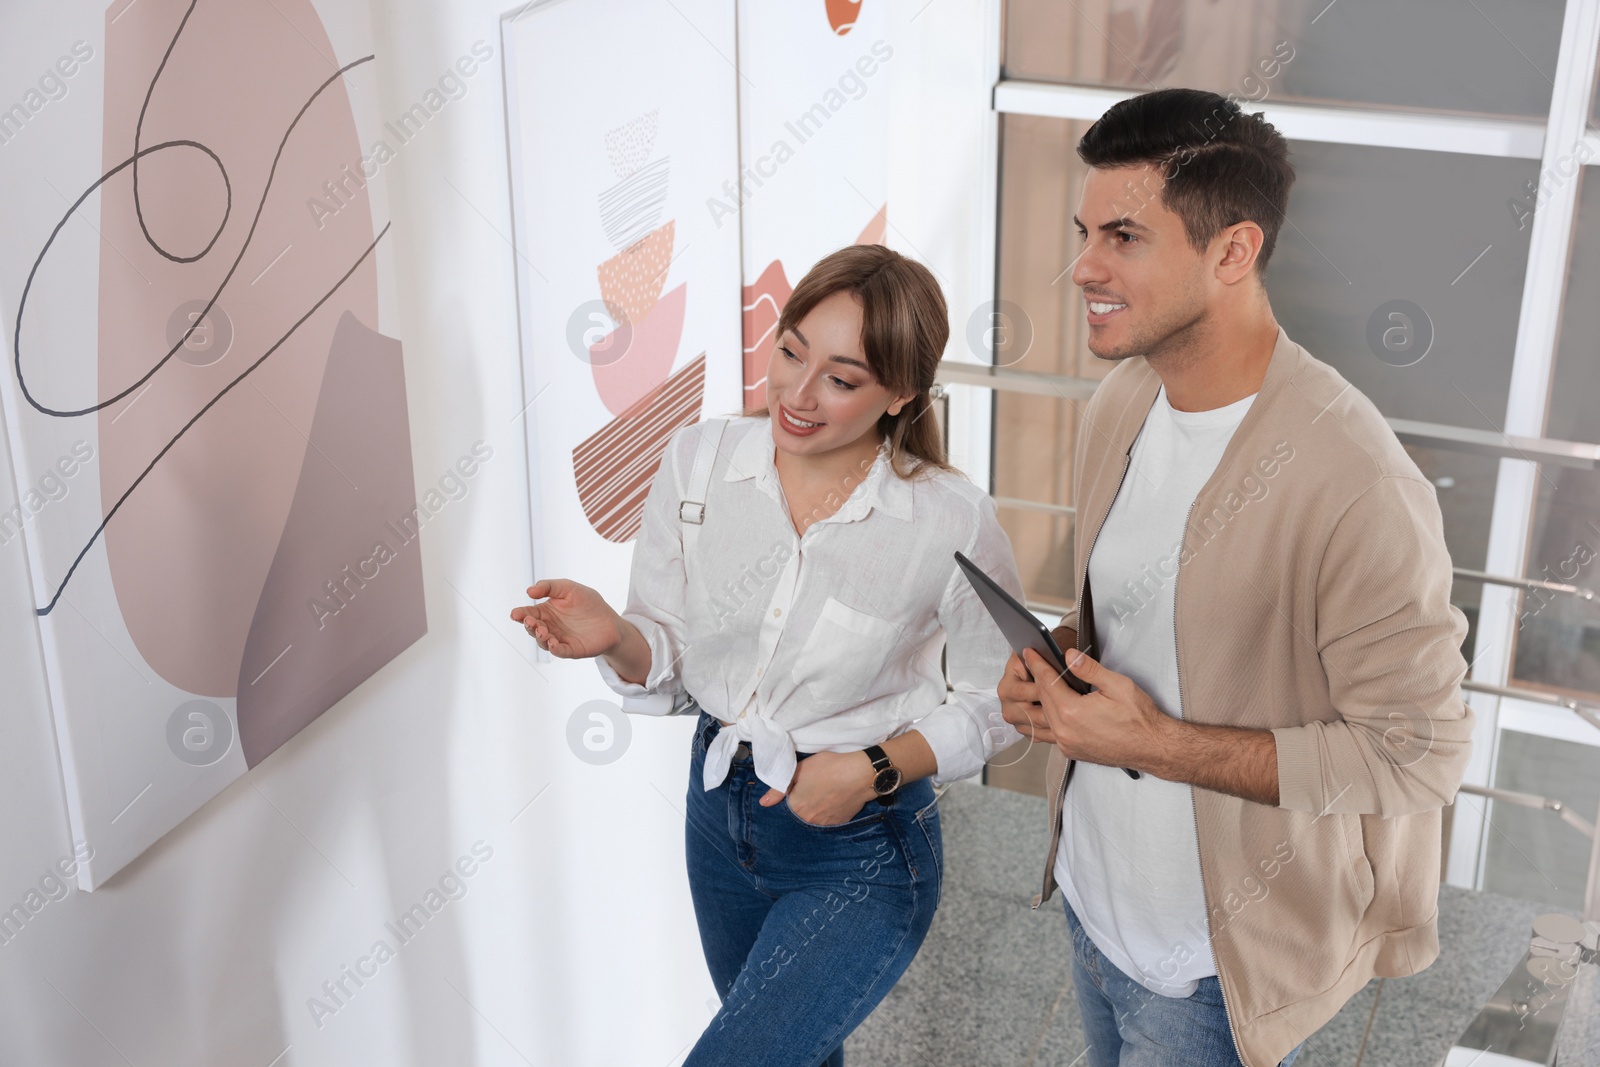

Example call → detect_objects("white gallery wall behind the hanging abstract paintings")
0 0 997 1067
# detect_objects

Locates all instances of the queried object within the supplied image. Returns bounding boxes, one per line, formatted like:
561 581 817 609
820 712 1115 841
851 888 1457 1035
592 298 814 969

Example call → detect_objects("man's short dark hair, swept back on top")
1078 90 1294 272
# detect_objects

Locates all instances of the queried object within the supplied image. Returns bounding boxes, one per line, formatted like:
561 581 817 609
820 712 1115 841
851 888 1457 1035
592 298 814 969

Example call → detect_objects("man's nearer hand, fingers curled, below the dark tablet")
1008 649 1178 767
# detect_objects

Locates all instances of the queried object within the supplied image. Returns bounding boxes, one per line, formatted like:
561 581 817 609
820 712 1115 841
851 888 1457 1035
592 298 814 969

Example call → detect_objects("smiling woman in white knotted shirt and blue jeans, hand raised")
512 245 1021 1067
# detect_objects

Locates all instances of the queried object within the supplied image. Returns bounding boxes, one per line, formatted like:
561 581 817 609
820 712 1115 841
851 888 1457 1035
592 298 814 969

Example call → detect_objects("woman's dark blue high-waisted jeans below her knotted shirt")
683 712 944 1067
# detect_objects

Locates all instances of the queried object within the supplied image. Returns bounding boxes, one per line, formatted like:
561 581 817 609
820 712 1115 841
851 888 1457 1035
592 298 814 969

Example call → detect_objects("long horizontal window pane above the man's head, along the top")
1005 0 1563 118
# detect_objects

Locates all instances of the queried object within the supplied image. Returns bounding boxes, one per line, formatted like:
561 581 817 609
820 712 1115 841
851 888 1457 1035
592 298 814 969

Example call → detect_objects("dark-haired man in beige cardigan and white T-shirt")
998 90 1472 1067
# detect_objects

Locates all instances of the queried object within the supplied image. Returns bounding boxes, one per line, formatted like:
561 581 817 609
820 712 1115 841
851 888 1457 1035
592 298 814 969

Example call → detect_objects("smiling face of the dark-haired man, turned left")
1072 165 1208 360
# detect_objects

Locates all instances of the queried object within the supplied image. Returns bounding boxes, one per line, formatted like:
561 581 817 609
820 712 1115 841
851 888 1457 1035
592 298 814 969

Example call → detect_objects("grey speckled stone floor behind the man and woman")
845 784 1600 1067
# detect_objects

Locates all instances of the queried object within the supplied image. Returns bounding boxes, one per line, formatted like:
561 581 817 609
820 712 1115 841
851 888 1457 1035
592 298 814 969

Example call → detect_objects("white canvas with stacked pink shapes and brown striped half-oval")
501 0 742 627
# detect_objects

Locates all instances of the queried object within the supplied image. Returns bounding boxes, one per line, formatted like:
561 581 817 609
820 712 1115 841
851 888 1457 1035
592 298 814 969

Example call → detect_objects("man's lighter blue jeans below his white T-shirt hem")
1061 893 1306 1067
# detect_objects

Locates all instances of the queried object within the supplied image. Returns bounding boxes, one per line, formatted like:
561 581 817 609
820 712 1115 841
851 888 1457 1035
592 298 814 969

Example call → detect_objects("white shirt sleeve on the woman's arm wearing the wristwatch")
917 496 1022 785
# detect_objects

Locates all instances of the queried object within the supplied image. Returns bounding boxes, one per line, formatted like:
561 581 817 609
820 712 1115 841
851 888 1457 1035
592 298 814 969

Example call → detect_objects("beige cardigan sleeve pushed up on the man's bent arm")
1272 477 1472 816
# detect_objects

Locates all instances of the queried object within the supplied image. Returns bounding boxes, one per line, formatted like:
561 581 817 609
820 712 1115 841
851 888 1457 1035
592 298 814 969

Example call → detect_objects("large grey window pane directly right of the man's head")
1267 141 1538 430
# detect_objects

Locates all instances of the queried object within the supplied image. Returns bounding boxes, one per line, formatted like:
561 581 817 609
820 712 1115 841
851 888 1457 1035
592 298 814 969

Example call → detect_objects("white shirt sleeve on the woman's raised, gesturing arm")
595 427 699 715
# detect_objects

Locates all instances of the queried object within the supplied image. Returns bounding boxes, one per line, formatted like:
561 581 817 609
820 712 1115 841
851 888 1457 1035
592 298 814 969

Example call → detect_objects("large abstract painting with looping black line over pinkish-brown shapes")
0 0 427 889
